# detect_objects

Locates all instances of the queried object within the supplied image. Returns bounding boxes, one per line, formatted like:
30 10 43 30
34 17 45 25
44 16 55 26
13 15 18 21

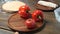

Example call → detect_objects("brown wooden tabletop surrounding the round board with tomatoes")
0 0 60 34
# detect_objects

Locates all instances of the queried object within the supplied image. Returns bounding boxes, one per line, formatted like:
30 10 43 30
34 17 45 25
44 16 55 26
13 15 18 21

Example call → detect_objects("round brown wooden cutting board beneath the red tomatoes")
8 13 44 32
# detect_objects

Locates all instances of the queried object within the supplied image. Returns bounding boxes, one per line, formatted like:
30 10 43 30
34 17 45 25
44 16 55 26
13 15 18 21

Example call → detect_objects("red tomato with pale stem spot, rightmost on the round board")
32 10 43 21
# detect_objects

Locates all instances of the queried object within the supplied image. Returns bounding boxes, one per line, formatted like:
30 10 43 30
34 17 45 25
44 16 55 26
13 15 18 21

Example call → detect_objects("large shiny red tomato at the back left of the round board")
18 5 30 18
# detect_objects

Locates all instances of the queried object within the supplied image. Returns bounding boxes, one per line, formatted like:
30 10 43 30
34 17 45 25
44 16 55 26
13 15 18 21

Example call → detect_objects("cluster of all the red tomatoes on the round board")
18 5 43 29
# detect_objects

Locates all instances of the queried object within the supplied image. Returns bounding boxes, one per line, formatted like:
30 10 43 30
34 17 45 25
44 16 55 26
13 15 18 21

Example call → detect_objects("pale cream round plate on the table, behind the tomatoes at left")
2 1 26 12
